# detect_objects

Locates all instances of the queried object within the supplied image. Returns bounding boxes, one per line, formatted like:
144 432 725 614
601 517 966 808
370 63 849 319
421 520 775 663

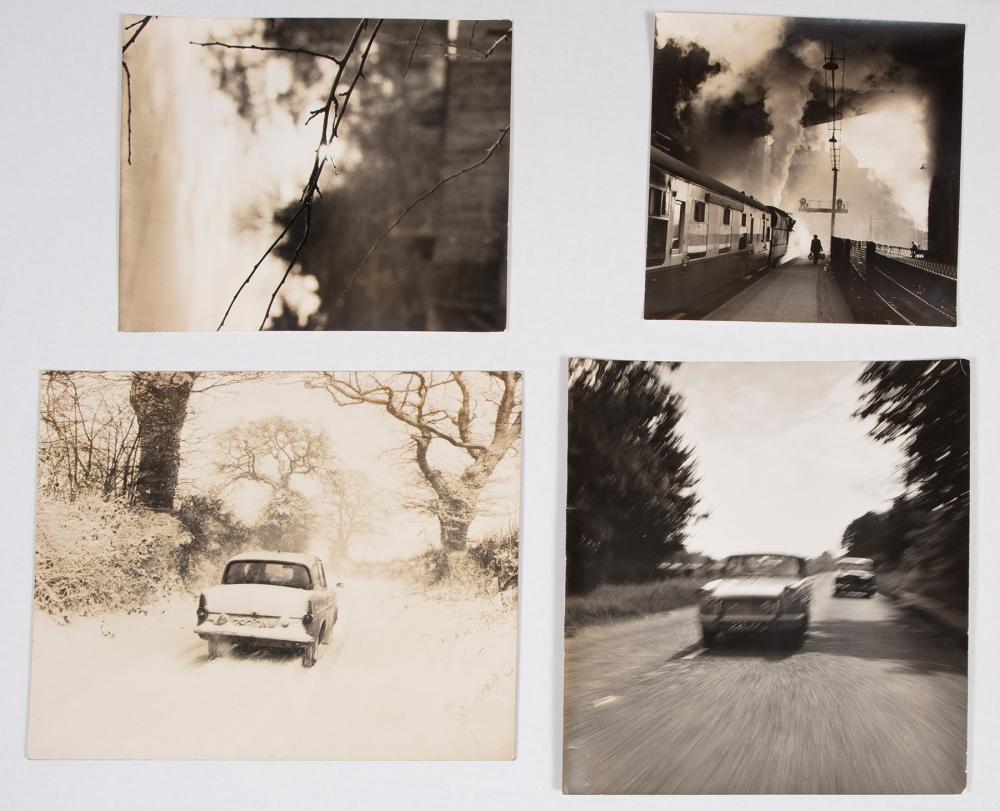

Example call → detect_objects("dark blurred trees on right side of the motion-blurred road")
843 360 970 607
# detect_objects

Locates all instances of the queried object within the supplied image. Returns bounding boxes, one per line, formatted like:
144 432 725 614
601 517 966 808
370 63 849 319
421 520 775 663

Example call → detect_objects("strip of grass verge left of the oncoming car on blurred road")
566 578 705 630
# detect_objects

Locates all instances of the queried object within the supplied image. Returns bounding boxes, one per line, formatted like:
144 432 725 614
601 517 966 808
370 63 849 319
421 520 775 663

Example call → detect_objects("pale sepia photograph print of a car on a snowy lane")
28 372 522 760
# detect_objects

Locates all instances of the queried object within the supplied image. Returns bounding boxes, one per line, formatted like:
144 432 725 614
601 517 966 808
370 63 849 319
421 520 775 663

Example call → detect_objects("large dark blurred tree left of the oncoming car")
566 360 699 594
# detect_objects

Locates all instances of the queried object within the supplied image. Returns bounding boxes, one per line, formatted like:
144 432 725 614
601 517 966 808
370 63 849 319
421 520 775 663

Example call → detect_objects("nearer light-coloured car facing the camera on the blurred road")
698 554 812 647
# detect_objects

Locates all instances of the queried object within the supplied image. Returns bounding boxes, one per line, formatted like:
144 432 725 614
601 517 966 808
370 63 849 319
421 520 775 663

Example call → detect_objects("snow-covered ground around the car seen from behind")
28 578 517 760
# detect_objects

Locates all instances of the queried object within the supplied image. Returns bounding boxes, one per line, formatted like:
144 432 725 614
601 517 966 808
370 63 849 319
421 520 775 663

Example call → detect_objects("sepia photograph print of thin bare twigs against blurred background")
119 15 512 332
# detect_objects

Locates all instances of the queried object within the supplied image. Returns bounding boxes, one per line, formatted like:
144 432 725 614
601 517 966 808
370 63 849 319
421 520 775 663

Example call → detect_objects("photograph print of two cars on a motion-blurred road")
563 359 970 794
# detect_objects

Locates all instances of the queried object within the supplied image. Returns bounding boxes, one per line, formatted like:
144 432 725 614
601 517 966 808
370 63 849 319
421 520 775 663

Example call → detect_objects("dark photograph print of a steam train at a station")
645 12 965 326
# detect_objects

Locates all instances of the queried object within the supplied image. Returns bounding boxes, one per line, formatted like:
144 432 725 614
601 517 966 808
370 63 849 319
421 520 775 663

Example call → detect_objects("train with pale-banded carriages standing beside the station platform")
645 146 794 318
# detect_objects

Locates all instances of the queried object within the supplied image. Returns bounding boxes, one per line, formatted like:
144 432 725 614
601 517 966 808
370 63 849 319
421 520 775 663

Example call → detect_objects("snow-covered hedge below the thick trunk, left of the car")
35 494 192 620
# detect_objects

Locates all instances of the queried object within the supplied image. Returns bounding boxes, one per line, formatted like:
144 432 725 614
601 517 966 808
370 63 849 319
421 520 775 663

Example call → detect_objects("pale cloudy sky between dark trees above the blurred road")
666 363 903 557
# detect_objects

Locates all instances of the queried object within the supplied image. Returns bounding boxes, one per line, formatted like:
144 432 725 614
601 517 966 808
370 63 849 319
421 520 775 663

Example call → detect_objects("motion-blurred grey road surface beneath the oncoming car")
563 574 967 794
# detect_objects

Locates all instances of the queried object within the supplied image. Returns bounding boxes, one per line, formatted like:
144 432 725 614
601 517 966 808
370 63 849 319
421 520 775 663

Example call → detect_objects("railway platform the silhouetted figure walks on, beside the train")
704 257 854 324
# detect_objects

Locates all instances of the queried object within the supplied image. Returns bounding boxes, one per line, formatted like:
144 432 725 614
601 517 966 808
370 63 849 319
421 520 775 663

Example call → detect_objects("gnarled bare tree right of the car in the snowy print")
306 372 521 551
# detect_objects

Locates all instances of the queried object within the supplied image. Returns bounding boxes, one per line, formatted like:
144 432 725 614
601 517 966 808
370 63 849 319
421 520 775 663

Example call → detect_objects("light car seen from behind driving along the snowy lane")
194 552 340 667
